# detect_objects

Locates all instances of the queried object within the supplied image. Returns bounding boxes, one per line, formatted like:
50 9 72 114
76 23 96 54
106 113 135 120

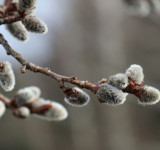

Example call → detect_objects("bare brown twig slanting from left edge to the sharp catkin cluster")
0 34 96 93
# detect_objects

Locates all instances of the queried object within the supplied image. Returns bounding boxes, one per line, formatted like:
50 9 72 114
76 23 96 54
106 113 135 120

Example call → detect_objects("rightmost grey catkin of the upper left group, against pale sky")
23 16 48 34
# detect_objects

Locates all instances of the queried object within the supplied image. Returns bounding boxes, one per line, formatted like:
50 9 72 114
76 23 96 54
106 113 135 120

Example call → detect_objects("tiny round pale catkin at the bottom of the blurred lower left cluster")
16 107 30 118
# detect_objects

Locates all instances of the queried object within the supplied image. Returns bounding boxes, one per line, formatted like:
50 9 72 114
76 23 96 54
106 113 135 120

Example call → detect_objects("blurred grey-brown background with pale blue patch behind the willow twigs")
0 0 160 150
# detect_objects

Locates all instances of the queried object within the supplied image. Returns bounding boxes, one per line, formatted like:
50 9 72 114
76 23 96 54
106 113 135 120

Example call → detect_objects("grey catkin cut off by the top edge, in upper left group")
18 0 37 15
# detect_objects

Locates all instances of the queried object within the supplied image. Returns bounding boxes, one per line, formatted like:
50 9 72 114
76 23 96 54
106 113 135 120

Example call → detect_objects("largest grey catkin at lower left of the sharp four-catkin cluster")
96 83 128 106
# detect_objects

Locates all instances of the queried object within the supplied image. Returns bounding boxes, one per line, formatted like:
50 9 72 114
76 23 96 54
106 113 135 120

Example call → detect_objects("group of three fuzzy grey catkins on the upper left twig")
6 0 48 41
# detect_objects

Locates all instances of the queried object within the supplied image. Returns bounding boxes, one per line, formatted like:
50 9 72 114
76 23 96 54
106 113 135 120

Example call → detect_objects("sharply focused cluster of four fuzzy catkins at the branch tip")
96 65 160 106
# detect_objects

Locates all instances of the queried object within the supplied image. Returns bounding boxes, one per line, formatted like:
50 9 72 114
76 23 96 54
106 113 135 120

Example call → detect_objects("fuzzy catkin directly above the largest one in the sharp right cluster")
108 73 128 89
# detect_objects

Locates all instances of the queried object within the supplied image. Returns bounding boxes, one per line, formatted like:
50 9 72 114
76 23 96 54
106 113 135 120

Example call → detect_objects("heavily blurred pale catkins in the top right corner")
123 0 160 17
